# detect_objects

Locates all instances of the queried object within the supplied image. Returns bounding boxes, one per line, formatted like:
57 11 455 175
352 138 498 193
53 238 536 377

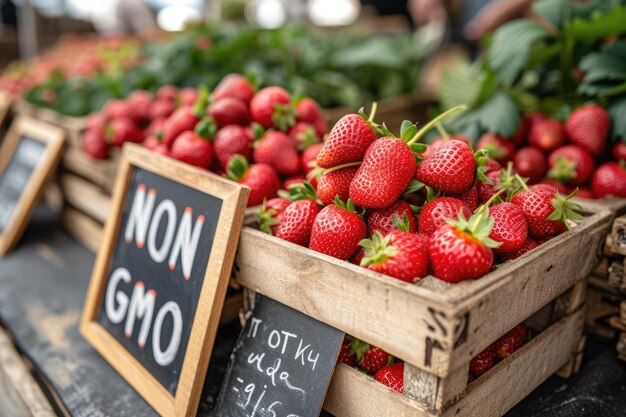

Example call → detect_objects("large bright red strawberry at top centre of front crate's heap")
348 137 417 208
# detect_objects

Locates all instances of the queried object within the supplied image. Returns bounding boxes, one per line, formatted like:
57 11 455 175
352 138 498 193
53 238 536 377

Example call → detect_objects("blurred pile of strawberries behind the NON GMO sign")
82 74 327 206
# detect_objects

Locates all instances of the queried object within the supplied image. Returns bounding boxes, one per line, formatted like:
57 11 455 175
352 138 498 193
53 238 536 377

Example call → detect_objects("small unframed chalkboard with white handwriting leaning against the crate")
215 295 344 417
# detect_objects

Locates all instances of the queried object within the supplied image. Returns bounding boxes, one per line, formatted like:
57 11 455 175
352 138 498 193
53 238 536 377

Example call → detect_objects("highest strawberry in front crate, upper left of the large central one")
317 114 376 168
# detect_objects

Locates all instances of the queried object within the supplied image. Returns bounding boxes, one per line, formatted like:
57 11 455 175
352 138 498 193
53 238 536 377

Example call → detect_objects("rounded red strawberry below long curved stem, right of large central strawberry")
417 140 476 194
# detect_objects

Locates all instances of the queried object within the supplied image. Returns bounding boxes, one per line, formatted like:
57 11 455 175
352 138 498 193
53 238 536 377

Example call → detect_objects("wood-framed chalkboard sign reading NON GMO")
81 145 248 416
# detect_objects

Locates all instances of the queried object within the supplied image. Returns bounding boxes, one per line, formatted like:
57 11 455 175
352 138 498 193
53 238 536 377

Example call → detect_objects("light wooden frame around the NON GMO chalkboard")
80 144 248 417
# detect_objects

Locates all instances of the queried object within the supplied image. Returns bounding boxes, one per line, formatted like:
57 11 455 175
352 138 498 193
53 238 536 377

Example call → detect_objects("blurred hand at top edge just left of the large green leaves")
464 0 533 40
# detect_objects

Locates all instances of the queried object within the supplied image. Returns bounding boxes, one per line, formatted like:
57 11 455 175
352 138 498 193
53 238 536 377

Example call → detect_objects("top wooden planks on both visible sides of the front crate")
236 210 612 377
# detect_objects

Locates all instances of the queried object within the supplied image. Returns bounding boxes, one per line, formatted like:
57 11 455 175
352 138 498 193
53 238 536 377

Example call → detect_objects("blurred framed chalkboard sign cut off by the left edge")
0 116 65 256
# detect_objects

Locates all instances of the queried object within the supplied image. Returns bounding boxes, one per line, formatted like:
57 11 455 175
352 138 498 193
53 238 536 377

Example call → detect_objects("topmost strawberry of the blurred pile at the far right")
565 104 611 156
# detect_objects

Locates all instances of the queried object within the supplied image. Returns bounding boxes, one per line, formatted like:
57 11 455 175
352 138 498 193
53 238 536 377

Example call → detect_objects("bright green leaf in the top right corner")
563 4 626 42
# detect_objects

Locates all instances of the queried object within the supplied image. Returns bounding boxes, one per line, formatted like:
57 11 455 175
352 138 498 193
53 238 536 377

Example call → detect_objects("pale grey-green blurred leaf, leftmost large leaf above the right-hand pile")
488 19 551 85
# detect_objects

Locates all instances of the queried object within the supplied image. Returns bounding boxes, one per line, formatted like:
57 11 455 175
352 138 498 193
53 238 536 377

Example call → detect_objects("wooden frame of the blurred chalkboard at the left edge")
0 116 65 256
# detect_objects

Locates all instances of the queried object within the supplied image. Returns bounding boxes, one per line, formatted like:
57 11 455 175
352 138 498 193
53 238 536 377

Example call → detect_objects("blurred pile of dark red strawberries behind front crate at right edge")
477 104 626 198
